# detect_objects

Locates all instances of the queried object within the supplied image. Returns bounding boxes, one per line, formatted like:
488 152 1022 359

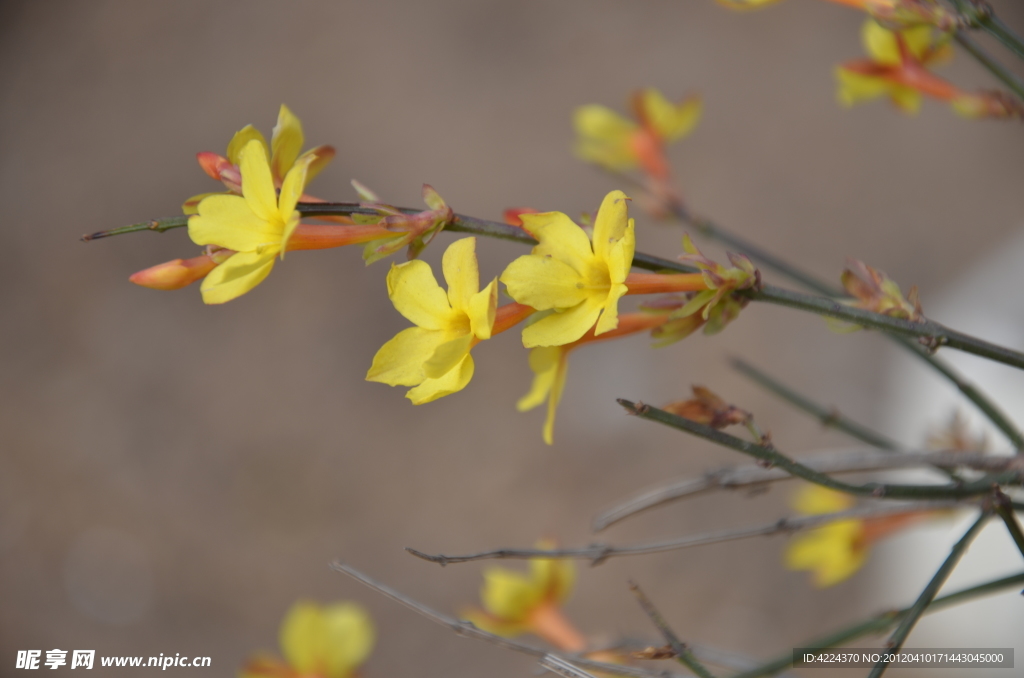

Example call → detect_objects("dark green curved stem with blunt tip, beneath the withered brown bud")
618 398 1022 499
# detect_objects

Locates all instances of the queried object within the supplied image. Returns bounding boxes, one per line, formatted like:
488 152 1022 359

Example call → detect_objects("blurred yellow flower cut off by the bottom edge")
239 602 375 678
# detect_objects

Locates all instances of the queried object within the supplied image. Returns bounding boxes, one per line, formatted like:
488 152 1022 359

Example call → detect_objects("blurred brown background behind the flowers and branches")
6 0 1024 678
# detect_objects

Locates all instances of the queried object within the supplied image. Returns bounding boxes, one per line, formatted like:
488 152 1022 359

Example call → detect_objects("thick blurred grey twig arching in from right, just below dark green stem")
593 449 1024 532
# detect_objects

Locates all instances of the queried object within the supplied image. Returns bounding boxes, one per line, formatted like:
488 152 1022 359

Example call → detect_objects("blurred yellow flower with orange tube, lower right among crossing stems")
785 485 937 588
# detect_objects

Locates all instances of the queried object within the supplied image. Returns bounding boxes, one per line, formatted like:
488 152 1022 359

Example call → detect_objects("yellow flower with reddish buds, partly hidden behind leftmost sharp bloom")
181 103 335 214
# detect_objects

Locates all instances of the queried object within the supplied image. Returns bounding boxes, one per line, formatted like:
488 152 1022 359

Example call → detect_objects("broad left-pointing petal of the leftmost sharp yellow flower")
188 194 281 252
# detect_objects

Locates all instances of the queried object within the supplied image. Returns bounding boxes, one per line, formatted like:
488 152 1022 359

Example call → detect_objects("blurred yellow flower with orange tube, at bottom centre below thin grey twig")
464 541 587 651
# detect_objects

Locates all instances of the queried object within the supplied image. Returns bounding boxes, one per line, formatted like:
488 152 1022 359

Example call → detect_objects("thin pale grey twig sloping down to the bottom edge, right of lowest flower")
330 560 681 678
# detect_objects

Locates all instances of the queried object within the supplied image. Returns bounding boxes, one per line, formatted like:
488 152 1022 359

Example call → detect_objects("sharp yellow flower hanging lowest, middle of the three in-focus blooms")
367 238 498 405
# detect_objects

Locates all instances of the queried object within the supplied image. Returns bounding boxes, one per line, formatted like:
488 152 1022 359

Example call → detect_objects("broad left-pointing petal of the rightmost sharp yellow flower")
500 254 589 310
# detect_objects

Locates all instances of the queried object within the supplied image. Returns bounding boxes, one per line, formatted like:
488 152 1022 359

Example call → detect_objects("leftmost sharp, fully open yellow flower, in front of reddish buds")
188 139 312 304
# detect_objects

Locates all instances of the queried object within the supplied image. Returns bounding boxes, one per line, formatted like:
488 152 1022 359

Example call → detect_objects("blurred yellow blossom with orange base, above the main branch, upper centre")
573 88 702 179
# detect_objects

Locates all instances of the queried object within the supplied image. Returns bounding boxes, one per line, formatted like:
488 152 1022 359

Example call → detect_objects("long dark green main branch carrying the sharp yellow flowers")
84 203 1024 369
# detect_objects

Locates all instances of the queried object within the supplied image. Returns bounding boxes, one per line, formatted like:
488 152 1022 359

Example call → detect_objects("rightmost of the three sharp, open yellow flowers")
501 190 636 348
